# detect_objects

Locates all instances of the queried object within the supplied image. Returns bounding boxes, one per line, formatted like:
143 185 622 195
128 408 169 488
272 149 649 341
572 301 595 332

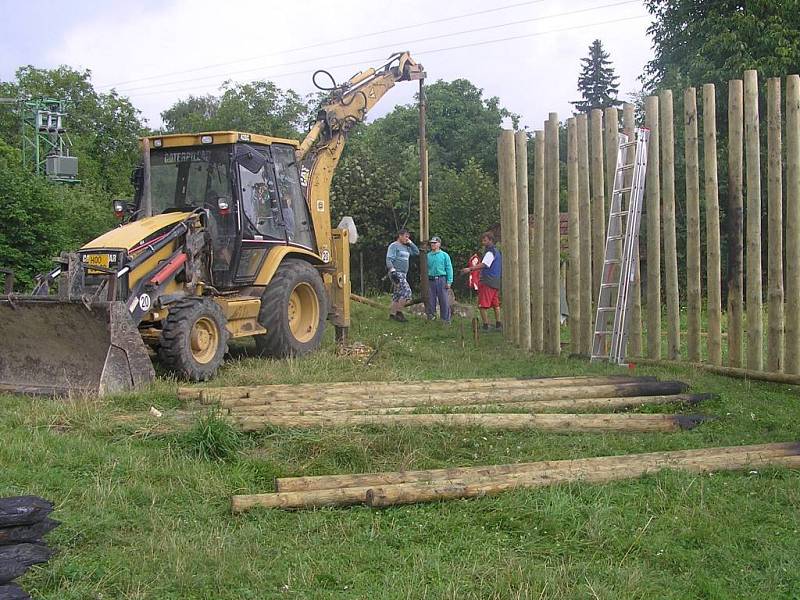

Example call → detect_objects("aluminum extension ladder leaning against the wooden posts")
591 128 650 364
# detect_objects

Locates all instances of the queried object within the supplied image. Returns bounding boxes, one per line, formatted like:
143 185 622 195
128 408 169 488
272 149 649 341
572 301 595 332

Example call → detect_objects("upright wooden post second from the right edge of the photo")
767 77 783 373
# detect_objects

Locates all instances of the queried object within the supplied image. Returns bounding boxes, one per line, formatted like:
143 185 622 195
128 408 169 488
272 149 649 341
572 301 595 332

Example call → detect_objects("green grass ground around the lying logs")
0 305 800 600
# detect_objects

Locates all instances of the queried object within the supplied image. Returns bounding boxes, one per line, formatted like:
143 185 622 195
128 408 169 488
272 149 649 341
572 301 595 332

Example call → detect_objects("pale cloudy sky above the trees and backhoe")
0 0 652 129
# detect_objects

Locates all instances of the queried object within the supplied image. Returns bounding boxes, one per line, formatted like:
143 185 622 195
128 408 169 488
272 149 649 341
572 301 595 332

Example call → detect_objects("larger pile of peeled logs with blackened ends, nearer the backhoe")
179 375 712 432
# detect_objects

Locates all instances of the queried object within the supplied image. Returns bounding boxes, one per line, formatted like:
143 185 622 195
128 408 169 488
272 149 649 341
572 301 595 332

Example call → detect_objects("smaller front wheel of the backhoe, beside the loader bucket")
158 298 230 381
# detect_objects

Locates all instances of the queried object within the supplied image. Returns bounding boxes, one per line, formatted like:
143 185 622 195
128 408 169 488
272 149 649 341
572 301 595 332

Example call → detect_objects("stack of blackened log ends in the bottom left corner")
0 496 59 600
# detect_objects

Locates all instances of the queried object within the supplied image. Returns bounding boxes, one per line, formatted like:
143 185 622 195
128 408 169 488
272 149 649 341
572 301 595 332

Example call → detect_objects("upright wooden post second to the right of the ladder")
659 90 681 360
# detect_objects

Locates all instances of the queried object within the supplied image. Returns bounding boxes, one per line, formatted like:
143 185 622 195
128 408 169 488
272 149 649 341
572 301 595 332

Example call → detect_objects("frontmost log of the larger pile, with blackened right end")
232 413 709 433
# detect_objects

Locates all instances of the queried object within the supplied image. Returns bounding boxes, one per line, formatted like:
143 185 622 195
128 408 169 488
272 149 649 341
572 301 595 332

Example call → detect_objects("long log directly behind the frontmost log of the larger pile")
229 394 716 417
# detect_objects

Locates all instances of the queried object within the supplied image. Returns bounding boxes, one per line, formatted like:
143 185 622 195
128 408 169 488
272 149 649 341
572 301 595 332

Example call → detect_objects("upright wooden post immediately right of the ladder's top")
644 96 661 360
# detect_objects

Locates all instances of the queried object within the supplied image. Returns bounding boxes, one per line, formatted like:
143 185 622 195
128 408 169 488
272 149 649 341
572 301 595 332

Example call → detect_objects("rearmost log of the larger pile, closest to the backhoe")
178 375 656 401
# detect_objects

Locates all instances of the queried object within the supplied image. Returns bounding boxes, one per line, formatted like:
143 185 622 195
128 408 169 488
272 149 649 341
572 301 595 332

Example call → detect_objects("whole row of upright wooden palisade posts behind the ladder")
498 71 800 374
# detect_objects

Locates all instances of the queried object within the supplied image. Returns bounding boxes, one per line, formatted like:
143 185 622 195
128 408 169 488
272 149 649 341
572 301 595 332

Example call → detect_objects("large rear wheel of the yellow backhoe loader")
256 258 328 358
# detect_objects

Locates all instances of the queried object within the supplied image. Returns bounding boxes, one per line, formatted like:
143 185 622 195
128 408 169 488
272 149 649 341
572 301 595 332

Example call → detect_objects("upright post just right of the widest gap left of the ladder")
567 117 585 354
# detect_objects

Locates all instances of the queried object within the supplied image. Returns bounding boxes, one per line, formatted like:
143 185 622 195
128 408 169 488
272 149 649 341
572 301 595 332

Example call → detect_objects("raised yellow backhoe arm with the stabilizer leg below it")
297 52 425 338
